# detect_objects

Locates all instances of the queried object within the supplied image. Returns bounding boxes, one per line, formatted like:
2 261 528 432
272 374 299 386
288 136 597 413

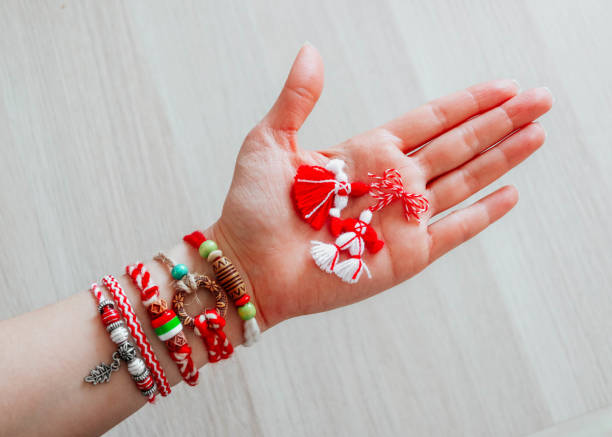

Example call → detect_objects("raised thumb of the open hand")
264 43 323 132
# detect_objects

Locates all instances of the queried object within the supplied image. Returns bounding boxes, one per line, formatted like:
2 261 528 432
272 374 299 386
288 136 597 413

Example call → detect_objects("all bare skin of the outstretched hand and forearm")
0 45 552 436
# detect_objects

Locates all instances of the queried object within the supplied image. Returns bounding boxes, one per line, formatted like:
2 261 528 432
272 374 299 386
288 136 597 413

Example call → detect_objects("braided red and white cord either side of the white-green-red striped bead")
125 263 200 385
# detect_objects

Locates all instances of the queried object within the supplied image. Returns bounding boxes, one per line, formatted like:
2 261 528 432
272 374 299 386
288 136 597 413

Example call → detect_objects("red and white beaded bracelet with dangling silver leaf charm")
85 282 157 402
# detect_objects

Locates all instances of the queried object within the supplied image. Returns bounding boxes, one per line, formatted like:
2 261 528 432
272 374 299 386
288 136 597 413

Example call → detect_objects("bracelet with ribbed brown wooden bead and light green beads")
183 231 261 346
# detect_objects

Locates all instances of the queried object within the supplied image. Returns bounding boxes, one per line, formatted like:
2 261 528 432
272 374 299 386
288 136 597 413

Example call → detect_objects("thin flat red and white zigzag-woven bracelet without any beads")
102 275 172 396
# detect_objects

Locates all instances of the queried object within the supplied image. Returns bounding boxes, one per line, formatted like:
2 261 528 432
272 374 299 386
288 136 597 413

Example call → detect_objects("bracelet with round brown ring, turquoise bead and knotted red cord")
155 252 234 363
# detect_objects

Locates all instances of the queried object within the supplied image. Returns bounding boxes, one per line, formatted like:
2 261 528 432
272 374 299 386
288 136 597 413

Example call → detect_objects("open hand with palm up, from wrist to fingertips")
212 45 552 327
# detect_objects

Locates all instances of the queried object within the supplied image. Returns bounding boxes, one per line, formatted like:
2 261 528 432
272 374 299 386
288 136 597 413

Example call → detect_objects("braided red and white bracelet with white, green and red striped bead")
125 263 200 386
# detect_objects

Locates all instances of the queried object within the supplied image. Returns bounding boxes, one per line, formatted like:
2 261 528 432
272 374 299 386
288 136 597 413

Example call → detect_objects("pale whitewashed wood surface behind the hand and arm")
0 0 612 436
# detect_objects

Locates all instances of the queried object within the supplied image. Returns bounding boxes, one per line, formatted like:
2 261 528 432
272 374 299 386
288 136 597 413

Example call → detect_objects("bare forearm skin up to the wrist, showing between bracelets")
0 223 263 435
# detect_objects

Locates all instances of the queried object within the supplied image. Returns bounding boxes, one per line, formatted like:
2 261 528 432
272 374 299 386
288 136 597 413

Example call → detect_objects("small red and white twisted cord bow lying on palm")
368 168 429 221
